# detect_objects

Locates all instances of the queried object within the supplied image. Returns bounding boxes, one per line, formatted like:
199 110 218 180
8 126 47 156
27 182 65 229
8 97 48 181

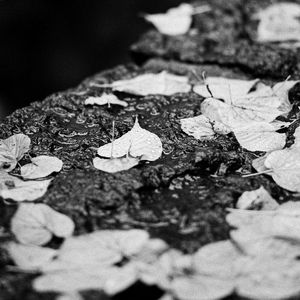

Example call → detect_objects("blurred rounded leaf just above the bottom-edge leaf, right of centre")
193 240 242 279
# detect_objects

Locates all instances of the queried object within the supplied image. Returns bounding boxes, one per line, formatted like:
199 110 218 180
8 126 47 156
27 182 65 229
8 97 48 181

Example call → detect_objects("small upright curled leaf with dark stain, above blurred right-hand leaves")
236 186 279 210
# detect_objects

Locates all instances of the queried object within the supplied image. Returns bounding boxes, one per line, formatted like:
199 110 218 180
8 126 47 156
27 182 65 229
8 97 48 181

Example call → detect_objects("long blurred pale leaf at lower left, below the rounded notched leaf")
43 230 149 272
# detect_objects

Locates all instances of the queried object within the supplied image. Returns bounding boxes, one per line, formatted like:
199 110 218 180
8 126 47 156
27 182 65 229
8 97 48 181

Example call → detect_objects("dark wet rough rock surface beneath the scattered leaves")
0 0 300 300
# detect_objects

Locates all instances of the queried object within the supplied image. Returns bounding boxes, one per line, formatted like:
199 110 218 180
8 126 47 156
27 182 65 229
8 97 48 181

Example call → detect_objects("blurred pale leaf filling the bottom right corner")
236 256 300 300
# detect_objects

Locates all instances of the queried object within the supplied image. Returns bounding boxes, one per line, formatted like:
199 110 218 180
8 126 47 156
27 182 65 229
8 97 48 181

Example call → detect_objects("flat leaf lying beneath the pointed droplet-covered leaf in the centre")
93 156 140 173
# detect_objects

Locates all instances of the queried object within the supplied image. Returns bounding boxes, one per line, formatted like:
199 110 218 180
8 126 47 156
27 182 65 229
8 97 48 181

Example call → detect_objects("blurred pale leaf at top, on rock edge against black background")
145 3 193 36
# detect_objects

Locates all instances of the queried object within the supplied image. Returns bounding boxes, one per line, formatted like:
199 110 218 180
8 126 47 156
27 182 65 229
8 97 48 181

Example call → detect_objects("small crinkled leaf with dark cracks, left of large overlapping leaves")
180 115 231 140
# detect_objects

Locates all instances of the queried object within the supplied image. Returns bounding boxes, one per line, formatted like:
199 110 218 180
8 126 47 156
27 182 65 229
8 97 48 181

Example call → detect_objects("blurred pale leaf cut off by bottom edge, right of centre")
171 276 234 300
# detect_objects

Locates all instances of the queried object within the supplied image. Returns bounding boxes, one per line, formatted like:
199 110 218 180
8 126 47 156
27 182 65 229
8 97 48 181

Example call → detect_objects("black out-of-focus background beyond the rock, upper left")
0 0 183 118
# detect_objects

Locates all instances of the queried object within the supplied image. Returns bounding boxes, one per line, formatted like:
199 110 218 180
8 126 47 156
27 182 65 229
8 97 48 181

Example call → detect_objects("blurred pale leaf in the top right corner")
256 2 300 42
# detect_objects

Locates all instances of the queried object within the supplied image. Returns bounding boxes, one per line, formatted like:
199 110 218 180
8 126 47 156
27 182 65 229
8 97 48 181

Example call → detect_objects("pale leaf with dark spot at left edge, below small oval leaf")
0 172 51 202
